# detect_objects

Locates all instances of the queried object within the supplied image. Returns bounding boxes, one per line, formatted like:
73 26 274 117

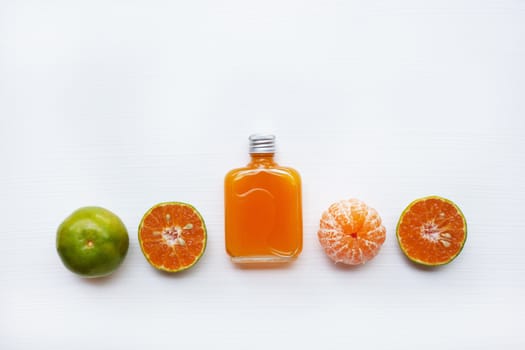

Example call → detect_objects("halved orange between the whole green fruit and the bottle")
139 202 207 272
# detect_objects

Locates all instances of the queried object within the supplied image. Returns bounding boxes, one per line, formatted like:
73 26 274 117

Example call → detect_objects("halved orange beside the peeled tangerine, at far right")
397 196 467 266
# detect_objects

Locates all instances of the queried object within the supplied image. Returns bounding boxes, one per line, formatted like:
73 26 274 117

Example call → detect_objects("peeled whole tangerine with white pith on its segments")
317 199 386 265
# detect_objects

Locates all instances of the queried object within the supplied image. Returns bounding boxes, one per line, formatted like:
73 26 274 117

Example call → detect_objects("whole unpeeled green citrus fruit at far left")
56 207 129 277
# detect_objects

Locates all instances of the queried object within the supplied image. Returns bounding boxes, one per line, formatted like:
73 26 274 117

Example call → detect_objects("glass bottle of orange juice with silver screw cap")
224 135 303 264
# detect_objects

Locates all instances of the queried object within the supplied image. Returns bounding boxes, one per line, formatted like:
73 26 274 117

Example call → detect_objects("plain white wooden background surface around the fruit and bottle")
0 0 525 350
